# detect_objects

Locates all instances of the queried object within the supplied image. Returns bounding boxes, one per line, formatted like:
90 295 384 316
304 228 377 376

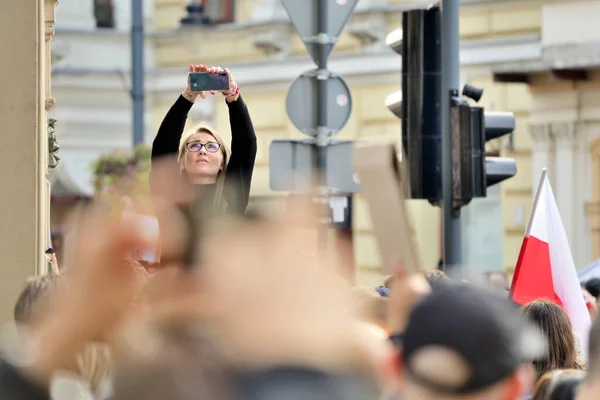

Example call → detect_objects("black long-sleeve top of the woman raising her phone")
151 96 257 214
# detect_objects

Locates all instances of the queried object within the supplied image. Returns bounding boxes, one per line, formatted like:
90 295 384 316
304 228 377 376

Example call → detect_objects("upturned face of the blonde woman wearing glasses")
184 132 223 184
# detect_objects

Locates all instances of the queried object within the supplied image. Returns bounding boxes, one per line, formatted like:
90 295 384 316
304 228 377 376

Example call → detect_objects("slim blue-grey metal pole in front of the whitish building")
131 0 144 147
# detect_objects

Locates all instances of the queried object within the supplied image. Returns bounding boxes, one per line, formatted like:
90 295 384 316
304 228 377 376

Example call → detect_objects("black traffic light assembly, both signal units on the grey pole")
385 7 517 209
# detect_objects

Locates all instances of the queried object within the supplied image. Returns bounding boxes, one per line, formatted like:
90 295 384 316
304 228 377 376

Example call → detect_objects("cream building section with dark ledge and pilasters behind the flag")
493 1 600 267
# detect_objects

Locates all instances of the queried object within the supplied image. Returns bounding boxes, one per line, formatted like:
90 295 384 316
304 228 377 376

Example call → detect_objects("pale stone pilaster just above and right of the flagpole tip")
550 121 578 259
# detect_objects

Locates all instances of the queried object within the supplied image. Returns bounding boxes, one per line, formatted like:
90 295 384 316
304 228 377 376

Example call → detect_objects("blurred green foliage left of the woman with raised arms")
91 145 151 211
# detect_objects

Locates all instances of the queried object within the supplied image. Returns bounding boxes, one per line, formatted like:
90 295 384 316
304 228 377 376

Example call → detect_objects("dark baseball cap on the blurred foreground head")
402 283 547 395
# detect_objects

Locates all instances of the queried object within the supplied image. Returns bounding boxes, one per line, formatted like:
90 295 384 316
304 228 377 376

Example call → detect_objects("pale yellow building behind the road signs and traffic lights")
153 0 542 284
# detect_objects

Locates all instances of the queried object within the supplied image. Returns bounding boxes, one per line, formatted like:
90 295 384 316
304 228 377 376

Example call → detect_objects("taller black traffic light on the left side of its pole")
385 7 442 204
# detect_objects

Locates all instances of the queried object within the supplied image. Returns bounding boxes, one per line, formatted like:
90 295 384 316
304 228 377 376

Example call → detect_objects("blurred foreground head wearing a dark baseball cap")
399 283 544 400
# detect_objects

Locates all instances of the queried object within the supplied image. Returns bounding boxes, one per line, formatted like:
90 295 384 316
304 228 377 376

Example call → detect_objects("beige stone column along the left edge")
0 0 53 321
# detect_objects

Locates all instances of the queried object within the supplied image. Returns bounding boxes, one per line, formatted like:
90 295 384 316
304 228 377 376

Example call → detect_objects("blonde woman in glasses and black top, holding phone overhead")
150 65 256 265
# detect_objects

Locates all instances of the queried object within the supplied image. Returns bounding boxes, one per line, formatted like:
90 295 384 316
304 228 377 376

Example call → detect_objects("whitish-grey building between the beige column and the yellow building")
50 0 154 255
